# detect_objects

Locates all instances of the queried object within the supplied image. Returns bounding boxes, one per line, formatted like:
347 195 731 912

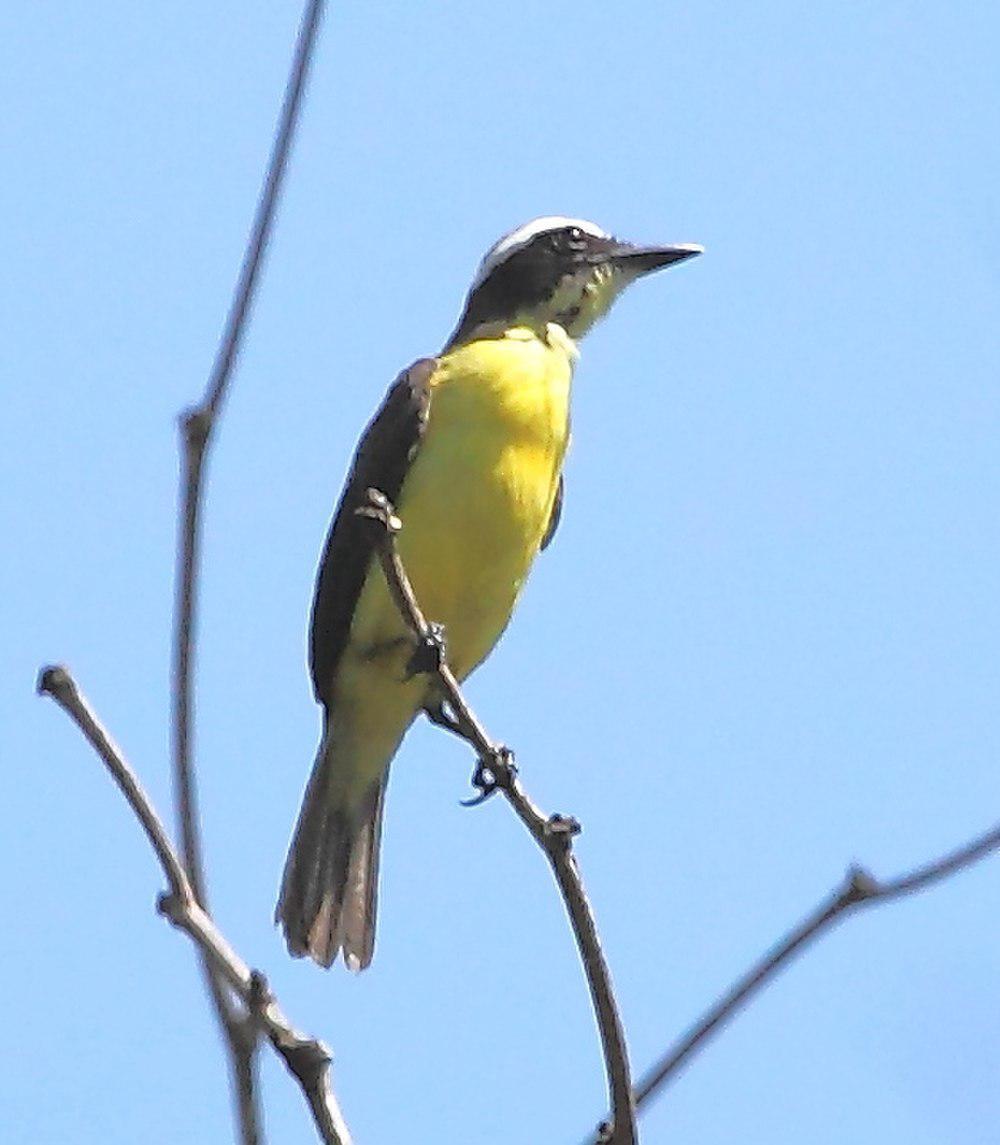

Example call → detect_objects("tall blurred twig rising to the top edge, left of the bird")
172 0 324 1145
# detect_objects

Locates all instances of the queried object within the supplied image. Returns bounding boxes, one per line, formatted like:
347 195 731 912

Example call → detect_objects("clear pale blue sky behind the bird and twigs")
0 0 1000 1145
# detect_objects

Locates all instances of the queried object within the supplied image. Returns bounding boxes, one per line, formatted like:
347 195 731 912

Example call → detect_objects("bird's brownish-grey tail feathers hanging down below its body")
275 740 388 970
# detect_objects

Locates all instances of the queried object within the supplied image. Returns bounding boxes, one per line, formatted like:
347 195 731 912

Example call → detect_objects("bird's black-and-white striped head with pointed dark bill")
449 215 702 346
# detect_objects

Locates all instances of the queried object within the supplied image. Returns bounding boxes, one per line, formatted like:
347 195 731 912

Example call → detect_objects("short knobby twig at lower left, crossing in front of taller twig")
38 666 351 1145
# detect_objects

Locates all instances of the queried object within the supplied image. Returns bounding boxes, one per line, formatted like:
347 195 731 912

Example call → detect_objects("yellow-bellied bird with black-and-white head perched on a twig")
275 215 702 971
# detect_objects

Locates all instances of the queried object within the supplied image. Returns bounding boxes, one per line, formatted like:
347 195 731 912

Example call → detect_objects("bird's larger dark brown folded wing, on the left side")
309 358 438 703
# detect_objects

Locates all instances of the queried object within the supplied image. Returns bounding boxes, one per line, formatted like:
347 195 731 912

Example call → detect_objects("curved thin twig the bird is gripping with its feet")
357 489 638 1145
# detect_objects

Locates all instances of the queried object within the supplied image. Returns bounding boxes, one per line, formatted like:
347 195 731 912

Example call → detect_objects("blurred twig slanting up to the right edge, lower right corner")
589 824 1000 1142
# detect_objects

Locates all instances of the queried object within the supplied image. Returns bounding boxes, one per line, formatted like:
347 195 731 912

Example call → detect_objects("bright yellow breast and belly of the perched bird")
336 330 572 792
